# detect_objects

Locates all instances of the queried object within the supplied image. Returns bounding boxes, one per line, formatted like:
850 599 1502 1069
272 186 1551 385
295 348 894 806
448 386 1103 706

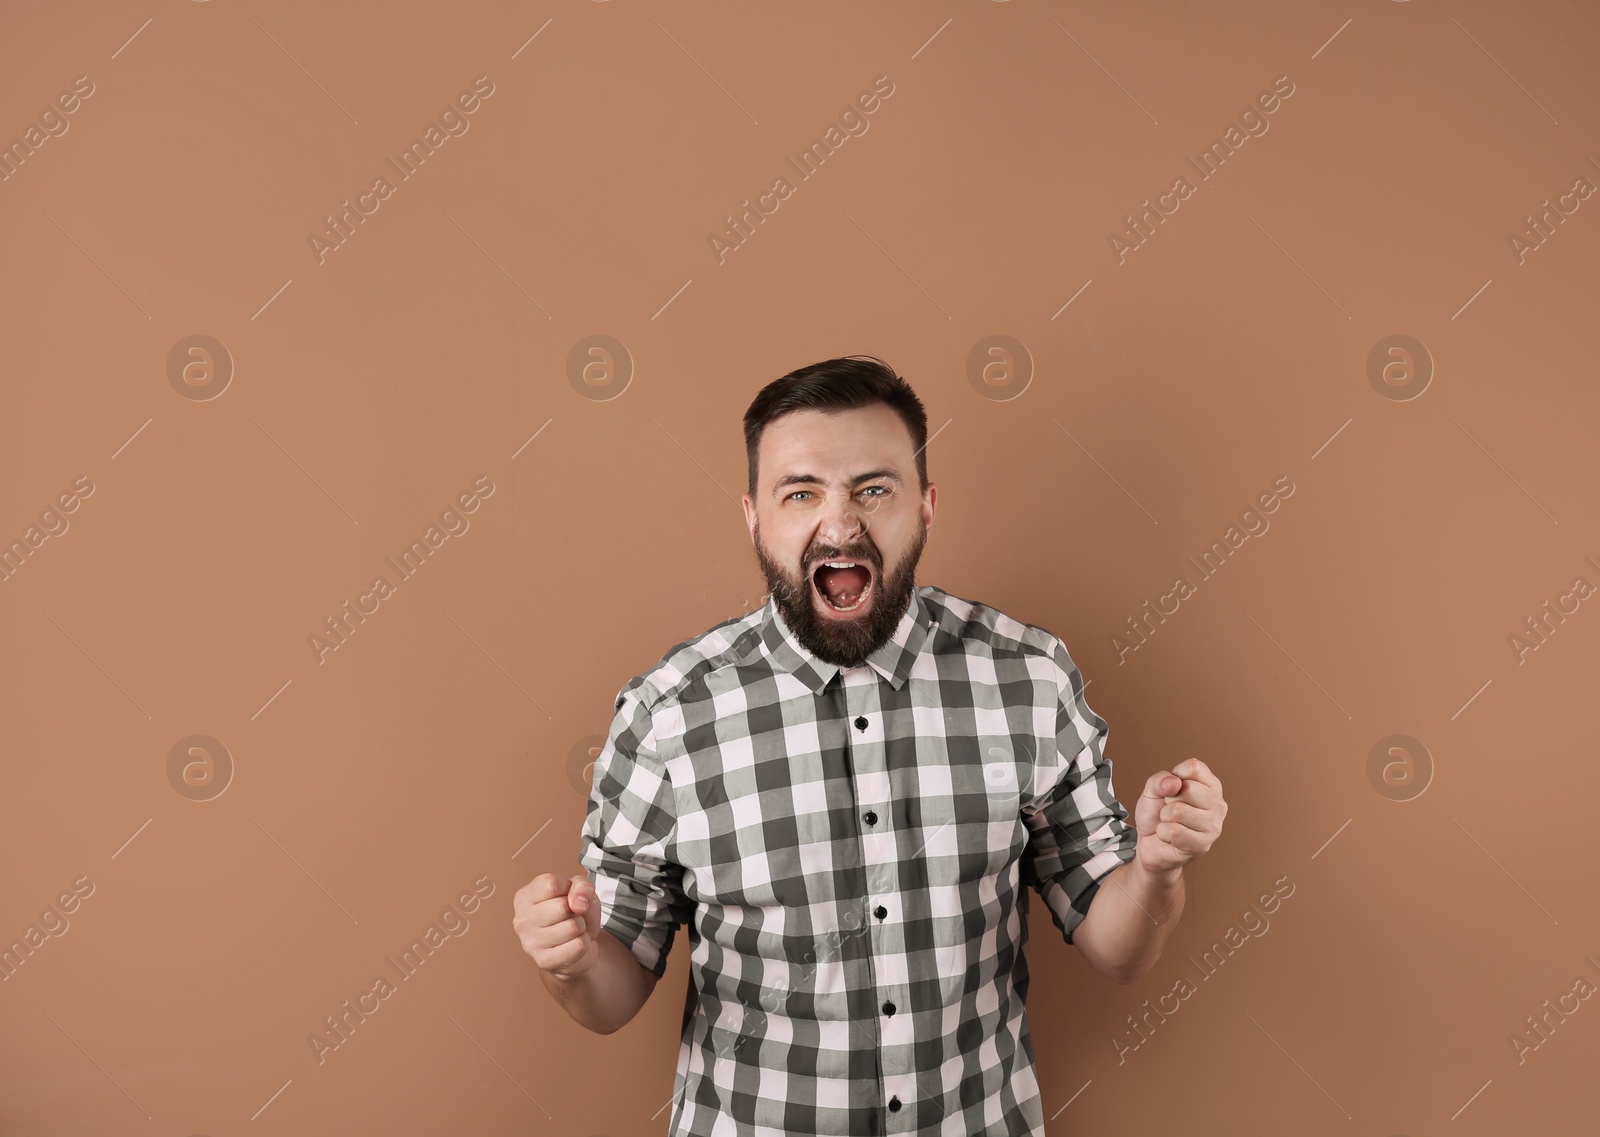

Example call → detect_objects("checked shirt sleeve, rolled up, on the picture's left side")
578 683 691 979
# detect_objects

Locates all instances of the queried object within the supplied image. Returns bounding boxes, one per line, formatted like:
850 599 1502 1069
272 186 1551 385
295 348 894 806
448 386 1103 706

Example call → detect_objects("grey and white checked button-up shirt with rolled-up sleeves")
579 585 1138 1137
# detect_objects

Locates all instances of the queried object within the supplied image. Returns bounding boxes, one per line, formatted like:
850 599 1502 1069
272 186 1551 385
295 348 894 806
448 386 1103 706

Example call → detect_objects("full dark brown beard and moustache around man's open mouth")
755 521 928 667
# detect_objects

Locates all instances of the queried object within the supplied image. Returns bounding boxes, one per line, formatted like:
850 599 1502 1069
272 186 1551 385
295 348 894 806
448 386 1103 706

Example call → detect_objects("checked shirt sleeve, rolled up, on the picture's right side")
1021 636 1139 944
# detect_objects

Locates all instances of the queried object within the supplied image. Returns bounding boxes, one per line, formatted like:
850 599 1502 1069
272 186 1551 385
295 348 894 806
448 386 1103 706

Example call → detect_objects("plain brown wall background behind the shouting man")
0 0 1600 1137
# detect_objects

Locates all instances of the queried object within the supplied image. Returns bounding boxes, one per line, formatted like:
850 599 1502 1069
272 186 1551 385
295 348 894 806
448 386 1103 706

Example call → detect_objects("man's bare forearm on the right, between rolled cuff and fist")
1072 857 1186 983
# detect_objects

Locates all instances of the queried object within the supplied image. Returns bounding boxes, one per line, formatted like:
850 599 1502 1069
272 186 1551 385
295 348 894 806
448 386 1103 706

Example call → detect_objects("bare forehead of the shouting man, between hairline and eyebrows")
760 403 915 485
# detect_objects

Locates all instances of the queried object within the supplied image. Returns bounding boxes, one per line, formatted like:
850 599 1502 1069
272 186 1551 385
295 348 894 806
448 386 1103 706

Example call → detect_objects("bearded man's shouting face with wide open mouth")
744 403 938 667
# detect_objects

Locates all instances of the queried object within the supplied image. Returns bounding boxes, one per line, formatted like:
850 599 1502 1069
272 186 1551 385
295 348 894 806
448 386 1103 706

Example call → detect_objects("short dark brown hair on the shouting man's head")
744 355 928 497
